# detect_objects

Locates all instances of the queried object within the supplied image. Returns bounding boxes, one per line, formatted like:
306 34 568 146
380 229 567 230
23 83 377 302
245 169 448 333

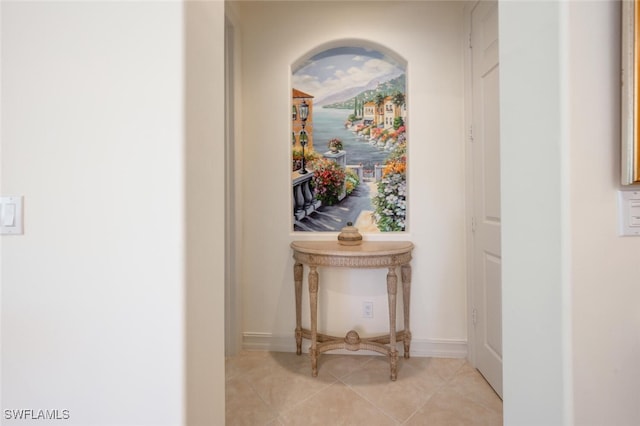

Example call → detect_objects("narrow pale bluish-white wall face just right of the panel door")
499 2 571 425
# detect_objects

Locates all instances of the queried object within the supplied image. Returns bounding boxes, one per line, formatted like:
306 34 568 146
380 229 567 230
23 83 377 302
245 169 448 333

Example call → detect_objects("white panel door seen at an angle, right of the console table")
470 1 502 397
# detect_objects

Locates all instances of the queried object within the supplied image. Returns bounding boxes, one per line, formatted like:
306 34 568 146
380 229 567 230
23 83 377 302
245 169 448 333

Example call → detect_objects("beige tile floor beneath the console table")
226 352 502 426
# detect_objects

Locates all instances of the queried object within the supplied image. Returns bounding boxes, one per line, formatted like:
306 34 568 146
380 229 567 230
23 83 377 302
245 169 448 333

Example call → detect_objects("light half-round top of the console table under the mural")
291 241 413 257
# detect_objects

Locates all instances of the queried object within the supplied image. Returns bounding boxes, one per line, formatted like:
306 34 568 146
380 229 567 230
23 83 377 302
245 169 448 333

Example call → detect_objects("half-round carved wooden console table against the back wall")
291 241 413 380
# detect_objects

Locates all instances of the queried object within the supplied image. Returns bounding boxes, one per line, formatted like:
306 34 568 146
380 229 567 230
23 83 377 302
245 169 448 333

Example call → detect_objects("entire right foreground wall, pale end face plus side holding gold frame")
500 1 640 425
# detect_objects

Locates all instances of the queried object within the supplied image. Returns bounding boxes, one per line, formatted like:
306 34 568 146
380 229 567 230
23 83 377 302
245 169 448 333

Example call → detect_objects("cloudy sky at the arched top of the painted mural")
292 47 404 100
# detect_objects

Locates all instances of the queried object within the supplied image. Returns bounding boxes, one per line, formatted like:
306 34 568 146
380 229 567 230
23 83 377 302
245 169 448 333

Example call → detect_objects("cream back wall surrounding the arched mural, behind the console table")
239 2 467 356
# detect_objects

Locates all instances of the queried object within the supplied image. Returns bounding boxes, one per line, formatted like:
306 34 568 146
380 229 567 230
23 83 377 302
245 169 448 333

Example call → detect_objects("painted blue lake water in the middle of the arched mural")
313 107 389 169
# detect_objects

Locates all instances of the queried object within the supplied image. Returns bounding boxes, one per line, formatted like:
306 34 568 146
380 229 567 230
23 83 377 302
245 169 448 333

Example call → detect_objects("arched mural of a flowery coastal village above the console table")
291 47 407 233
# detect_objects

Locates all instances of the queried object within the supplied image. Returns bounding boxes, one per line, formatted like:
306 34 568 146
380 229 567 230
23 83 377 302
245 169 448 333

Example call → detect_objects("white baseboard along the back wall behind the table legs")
242 333 467 358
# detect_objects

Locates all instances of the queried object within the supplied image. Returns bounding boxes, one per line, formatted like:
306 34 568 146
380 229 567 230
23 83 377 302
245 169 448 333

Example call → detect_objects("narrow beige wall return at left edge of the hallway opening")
183 1 226 425
